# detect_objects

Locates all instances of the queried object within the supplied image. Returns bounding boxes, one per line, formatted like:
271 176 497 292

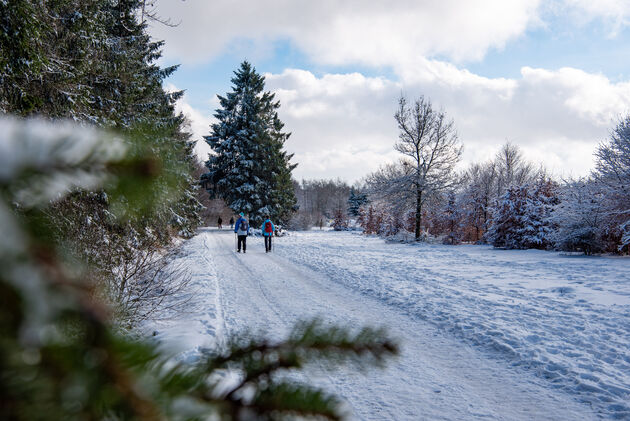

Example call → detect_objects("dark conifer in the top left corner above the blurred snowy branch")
0 0 105 115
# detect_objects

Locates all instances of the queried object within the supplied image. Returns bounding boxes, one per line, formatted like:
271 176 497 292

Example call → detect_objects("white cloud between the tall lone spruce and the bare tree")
265 69 401 180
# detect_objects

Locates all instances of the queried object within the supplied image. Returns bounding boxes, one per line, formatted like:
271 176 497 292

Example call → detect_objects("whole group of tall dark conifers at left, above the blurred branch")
0 0 200 237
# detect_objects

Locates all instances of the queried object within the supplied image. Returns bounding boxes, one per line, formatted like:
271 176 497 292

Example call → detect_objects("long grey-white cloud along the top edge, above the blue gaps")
152 0 540 66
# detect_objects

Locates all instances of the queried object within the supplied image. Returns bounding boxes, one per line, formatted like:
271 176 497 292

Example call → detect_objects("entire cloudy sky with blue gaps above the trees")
152 0 630 182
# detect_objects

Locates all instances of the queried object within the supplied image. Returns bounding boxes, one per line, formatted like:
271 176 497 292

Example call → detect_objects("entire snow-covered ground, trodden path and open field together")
158 229 630 420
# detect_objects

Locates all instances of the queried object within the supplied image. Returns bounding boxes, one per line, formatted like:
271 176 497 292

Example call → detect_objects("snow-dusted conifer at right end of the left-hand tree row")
85 0 201 237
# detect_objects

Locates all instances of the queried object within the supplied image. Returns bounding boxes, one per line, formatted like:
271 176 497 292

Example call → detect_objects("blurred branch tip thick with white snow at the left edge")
0 117 127 207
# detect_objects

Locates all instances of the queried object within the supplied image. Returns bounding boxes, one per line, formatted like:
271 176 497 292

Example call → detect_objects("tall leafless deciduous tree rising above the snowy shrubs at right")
394 96 462 239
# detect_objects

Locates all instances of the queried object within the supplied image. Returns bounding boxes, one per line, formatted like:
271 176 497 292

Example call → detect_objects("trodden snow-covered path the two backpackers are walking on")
154 229 608 420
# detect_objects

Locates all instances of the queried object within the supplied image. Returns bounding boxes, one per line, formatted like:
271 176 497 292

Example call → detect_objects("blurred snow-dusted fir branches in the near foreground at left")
0 120 398 420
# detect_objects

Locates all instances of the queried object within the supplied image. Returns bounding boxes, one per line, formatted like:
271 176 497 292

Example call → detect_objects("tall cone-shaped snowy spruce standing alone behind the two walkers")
202 61 296 223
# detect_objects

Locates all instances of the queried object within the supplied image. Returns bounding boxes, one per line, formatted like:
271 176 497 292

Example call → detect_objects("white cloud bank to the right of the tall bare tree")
406 63 630 175
